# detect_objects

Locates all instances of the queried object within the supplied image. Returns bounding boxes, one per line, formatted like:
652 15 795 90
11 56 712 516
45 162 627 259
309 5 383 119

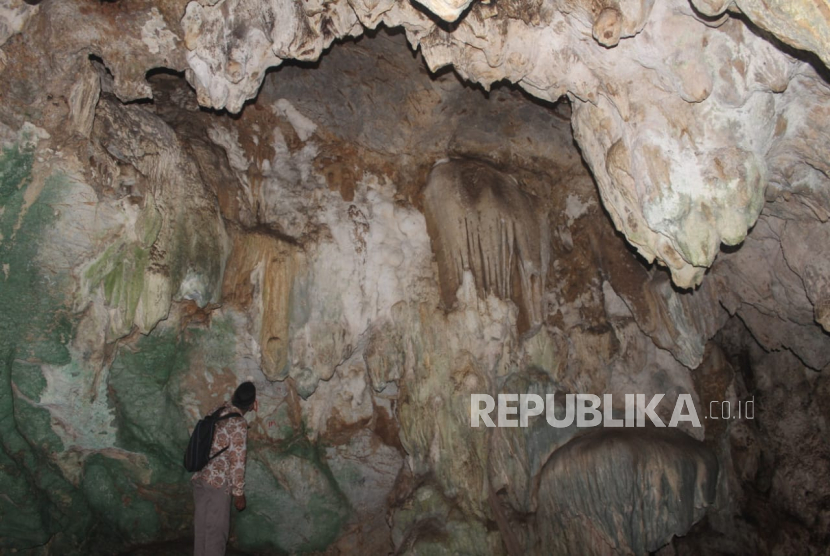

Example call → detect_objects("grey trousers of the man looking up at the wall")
193 481 231 556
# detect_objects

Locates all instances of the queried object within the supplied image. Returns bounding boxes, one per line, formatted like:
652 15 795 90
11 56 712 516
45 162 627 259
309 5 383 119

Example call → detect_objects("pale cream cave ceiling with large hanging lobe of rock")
6 0 830 296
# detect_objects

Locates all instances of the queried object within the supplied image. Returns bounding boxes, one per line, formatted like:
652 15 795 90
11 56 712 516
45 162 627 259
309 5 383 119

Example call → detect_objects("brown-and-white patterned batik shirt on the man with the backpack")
192 403 248 496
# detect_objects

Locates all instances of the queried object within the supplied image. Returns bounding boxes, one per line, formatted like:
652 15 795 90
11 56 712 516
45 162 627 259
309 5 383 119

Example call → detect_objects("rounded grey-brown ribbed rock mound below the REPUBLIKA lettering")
537 429 718 555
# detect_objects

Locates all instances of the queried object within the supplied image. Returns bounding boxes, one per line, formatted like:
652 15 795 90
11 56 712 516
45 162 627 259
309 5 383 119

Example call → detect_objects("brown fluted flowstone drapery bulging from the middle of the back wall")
424 160 550 331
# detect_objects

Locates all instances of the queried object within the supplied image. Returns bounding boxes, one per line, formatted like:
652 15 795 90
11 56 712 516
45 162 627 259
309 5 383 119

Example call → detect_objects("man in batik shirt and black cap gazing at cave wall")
191 382 258 556
